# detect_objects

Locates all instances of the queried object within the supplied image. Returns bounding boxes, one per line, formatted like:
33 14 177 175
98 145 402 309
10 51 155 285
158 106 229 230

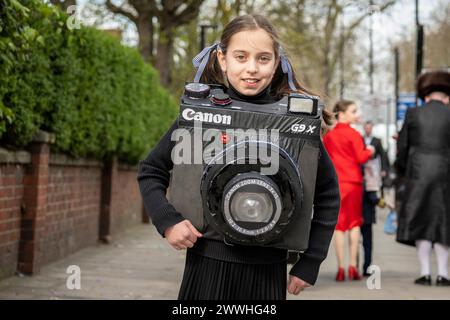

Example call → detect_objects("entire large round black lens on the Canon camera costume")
200 141 303 245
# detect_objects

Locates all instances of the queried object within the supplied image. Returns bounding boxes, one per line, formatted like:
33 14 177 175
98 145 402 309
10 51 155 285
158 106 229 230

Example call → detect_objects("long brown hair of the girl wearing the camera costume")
200 14 332 125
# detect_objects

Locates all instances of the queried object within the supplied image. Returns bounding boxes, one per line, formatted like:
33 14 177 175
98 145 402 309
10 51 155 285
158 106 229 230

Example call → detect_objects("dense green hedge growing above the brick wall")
0 0 178 164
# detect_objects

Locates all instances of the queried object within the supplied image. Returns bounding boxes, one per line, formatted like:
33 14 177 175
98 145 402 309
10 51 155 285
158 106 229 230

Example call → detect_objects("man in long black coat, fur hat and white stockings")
396 71 450 286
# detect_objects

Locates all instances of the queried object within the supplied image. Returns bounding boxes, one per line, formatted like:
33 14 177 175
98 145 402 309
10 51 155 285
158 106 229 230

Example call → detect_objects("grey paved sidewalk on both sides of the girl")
0 211 450 300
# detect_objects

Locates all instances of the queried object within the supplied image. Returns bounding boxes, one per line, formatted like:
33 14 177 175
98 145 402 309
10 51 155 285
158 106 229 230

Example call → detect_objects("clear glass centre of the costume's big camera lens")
230 192 273 222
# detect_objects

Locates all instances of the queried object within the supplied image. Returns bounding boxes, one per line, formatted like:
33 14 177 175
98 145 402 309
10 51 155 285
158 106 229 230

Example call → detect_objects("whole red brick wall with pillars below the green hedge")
0 136 143 279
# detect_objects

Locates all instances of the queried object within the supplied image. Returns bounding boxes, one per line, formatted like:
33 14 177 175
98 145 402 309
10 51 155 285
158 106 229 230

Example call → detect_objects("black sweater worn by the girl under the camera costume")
138 89 340 284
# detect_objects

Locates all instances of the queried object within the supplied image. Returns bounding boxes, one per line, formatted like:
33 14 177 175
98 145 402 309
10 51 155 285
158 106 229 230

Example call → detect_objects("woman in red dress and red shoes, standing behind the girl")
323 100 375 281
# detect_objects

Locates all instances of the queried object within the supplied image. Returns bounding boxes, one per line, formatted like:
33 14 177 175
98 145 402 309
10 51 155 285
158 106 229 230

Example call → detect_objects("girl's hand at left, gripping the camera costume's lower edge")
164 220 203 250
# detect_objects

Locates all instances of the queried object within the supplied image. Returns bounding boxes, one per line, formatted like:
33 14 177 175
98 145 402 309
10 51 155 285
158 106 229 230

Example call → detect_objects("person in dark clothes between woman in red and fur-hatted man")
361 121 389 276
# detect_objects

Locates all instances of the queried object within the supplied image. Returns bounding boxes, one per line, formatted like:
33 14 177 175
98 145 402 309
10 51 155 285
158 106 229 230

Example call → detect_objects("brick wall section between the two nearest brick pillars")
42 163 102 264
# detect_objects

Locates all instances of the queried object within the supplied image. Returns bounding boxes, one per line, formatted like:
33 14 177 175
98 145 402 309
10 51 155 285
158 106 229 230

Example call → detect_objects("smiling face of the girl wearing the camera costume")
217 29 278 96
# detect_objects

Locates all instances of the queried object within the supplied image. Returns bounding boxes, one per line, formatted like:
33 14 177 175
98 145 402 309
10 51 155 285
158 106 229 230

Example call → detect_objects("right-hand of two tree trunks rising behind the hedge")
155 27 175 86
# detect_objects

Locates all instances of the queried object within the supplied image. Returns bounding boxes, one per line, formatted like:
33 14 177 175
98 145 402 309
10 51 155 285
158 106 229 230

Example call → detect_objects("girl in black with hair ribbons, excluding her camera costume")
138 15 339 300
